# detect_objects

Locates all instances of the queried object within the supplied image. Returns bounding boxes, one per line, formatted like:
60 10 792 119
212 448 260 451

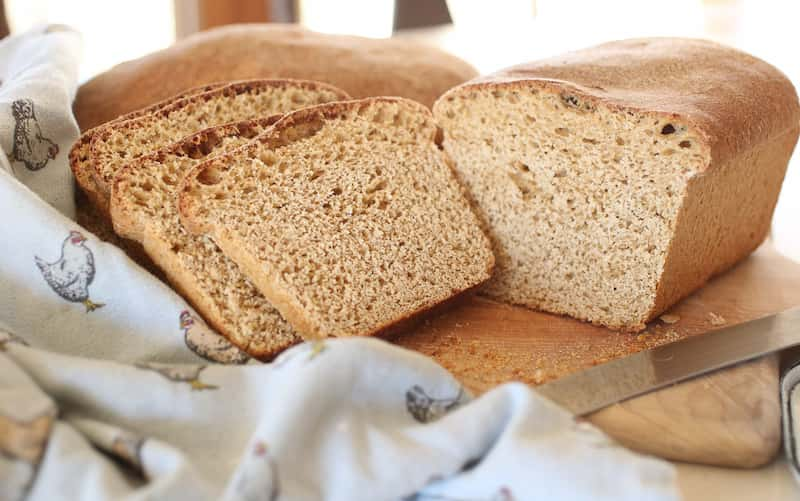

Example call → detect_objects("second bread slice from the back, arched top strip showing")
89 80 348 209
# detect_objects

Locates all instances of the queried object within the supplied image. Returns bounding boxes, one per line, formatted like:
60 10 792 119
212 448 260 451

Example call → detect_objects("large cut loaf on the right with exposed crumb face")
434 39 800 331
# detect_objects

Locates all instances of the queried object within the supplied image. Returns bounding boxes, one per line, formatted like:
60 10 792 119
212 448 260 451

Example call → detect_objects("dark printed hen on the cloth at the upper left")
11 99 58 170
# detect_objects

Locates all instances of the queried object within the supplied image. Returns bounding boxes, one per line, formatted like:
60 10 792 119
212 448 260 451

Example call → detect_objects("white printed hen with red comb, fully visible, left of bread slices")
34 231 105 313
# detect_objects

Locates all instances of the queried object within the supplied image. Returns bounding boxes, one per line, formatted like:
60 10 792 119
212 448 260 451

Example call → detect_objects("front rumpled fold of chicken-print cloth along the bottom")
0 336 678 501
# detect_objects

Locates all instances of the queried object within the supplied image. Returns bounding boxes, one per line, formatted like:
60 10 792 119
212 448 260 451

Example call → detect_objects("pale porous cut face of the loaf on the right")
437 86 705 327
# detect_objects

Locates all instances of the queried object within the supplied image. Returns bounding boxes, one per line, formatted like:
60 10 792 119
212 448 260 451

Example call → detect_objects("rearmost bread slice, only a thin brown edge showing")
69 83 227 213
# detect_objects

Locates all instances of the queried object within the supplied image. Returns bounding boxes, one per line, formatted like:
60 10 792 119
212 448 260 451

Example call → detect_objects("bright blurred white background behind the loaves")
0 0 800 260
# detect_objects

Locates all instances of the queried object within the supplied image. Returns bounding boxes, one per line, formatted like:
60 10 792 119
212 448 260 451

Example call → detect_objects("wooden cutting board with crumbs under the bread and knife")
394 245 800 467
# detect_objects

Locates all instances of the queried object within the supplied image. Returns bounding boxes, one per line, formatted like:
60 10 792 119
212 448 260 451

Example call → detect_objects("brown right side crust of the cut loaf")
641 126 800 322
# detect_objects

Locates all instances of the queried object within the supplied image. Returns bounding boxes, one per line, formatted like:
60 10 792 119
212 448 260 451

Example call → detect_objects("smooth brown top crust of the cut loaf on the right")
434 38 800 165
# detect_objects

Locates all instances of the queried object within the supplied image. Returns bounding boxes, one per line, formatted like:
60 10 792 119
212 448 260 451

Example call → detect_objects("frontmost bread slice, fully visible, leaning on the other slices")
180 98 494 338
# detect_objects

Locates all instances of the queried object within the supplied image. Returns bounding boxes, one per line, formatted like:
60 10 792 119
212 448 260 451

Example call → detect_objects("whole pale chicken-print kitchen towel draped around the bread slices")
0 27 678 501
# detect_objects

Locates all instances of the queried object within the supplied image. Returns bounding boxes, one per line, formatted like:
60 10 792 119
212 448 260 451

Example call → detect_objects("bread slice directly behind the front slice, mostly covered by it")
111 115 300 360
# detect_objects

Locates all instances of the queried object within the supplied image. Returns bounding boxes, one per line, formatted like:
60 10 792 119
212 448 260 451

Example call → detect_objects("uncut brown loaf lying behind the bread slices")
74 24 476 130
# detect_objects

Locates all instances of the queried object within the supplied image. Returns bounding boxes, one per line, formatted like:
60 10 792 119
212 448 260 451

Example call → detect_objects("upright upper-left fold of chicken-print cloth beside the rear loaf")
0 25 81 217
